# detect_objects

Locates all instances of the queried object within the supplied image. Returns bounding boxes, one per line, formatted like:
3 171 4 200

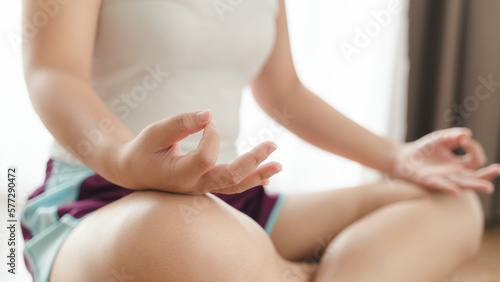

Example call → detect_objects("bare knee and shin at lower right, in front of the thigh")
317 187 483 281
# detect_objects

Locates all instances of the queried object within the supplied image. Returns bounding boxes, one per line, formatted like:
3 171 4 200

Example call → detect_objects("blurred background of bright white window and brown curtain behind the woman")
0 0 500 281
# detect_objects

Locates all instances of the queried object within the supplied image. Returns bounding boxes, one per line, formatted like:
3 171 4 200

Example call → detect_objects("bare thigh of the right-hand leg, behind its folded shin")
271 180 431 261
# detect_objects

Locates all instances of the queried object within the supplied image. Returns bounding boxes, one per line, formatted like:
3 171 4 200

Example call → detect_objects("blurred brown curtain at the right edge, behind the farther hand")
407 0 500 225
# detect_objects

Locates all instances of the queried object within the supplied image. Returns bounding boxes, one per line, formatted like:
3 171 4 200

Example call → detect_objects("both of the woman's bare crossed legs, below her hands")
50 182 482 282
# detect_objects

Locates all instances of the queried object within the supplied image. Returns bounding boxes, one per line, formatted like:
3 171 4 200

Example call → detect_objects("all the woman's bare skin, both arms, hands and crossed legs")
23 0 500 282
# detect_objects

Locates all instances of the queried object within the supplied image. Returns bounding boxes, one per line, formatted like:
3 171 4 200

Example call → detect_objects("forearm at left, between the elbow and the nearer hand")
26 69 134 180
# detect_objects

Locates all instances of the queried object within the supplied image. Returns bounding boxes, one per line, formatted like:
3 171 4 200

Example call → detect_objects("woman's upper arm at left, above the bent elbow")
23 0 101 81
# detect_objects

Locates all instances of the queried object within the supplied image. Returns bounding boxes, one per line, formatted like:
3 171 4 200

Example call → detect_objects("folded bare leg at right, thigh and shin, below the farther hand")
271 181 483 282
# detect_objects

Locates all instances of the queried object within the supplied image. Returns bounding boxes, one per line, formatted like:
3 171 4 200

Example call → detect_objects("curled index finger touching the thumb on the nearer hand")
174 122 220 179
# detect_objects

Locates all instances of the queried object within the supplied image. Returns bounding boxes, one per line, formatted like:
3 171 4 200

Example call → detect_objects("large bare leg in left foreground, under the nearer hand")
50 191 311 282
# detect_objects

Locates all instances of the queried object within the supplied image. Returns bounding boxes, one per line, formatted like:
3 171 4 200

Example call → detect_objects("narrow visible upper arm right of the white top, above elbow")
251 0 300 105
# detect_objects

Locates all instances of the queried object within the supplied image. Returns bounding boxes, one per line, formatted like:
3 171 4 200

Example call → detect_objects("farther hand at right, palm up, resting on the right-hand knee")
389 128 500 195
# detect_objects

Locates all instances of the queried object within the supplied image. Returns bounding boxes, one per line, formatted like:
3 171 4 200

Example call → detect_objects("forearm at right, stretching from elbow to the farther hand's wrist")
259 84 399 172
